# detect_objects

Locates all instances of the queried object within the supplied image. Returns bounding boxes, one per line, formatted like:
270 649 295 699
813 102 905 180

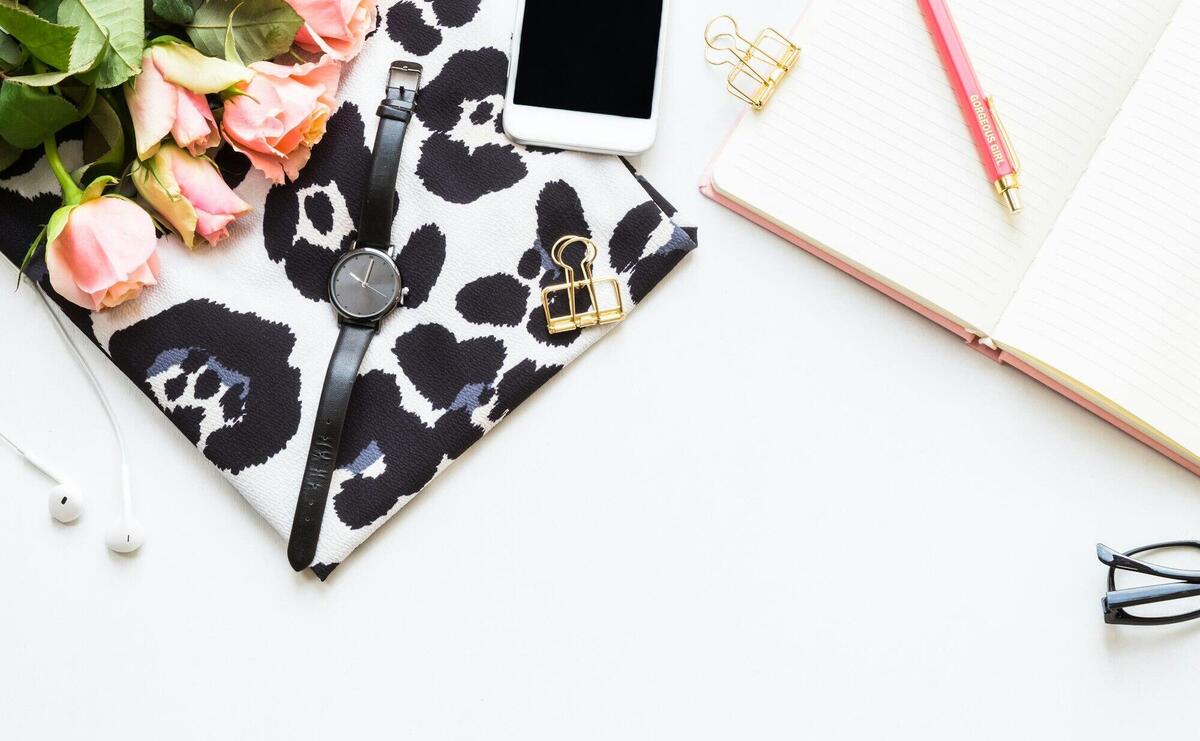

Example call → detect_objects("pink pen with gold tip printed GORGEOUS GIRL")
917 0 1024 213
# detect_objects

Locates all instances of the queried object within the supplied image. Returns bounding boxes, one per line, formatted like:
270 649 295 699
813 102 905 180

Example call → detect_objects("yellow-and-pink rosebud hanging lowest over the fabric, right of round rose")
132 143 250 247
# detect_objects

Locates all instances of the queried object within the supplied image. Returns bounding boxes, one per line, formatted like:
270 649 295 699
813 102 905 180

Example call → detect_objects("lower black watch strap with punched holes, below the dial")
288 324 376 571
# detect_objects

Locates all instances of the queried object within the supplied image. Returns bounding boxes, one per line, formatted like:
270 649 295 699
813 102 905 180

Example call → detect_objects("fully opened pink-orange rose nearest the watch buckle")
221 56 342 182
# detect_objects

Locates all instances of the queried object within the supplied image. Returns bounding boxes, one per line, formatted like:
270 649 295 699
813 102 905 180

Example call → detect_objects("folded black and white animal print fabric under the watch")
0 0 696 578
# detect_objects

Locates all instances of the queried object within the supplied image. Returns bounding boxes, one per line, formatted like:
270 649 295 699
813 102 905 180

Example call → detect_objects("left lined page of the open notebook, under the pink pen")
712 0 1178 335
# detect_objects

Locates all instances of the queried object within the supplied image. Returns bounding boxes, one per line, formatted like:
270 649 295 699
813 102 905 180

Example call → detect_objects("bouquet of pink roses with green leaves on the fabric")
0 0 376 311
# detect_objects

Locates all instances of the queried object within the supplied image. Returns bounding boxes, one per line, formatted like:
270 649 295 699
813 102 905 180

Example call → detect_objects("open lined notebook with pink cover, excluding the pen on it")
702 0 1200 474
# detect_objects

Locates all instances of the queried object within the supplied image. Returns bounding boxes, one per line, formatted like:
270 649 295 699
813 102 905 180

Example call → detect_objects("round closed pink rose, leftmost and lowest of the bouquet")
46 195 158 312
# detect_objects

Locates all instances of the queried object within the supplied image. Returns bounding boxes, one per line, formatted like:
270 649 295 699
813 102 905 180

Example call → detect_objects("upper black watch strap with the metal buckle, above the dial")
359 62 421 253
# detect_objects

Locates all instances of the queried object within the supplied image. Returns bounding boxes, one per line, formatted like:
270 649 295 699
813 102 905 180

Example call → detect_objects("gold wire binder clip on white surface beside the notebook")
704 16 800 110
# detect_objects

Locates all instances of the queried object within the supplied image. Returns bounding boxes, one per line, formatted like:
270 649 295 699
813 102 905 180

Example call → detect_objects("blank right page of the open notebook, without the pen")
995 2 1200 458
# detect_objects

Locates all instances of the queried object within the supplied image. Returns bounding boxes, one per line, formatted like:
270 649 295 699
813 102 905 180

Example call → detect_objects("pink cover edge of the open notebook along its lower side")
700 158 1200 476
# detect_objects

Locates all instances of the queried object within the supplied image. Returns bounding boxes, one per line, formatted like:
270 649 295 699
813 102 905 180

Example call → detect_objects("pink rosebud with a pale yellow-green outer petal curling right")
125 41 251 159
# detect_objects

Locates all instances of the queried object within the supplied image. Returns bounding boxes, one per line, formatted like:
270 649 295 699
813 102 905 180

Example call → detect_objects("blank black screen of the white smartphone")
514 0 662 119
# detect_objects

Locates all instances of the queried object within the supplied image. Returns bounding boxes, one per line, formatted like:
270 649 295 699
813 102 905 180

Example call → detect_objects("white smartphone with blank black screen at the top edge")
504 0 667 155
